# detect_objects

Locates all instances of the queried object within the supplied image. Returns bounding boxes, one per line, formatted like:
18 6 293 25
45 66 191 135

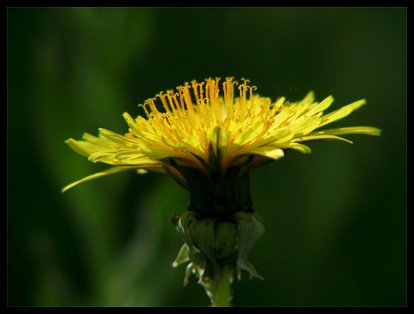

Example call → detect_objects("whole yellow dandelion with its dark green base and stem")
63 78 380 305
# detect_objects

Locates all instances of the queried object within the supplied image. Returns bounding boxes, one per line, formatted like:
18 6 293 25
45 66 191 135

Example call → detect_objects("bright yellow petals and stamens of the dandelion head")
64 78 380 190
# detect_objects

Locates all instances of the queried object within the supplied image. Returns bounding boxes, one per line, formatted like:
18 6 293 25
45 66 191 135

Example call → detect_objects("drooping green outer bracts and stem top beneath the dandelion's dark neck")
173 211 264 304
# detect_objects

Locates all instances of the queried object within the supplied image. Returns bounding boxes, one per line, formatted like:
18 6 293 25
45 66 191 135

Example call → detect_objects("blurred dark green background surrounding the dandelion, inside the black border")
7 8 407 306
